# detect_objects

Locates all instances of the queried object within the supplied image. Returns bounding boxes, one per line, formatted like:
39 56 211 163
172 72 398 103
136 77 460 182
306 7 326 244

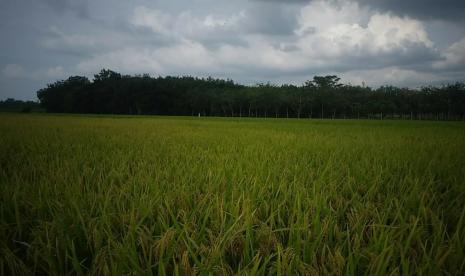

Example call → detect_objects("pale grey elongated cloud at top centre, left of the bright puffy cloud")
130 4 297 43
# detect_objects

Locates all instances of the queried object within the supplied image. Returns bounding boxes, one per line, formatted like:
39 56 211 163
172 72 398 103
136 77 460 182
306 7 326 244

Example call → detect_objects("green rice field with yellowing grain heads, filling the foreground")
0 114 465 275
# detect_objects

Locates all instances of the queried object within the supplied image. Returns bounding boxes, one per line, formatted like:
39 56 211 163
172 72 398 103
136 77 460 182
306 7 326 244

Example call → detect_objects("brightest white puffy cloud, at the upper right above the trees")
296 1 438 69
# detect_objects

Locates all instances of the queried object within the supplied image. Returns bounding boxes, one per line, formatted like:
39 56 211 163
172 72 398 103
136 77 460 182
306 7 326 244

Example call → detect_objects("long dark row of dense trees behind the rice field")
37 70 465 120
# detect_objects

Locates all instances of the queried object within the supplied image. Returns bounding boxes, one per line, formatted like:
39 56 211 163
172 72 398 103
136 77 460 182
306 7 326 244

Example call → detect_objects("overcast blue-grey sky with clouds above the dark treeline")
0 0 465 100
